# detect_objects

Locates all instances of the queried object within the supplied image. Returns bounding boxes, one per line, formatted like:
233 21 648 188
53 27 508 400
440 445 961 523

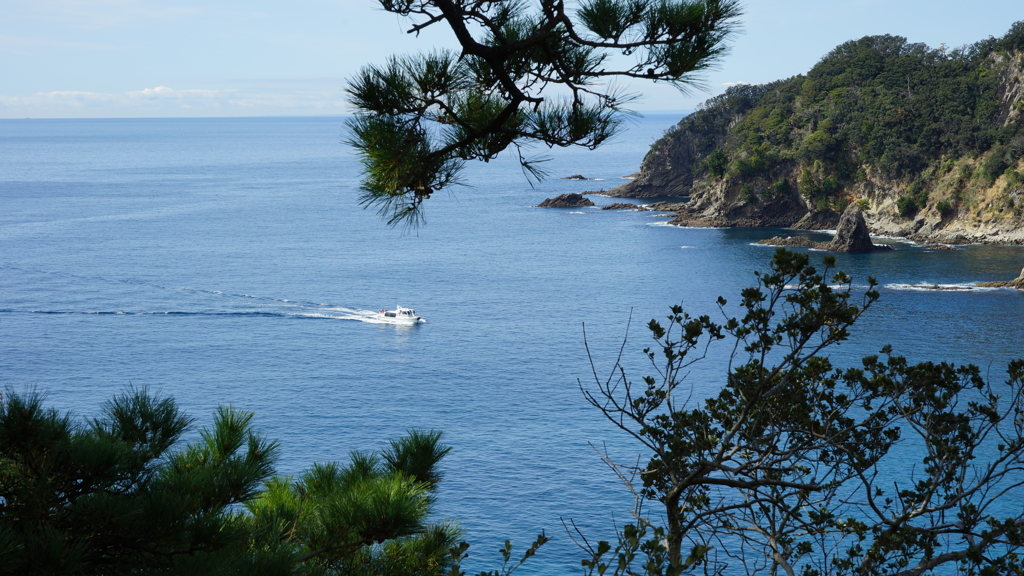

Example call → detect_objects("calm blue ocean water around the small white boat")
0 115 1024 574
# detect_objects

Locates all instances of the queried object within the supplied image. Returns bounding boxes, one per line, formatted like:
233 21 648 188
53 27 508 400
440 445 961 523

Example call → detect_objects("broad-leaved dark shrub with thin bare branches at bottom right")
581 249 1024 576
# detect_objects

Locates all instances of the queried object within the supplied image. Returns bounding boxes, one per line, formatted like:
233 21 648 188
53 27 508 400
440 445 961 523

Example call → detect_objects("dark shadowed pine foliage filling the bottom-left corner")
0 390 278 575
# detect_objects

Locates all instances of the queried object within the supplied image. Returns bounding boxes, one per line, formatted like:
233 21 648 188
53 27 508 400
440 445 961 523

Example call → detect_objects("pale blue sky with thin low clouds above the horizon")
0 0 1024 119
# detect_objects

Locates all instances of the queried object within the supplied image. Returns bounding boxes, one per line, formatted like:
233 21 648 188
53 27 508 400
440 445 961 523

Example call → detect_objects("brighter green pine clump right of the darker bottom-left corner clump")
247 430 462 576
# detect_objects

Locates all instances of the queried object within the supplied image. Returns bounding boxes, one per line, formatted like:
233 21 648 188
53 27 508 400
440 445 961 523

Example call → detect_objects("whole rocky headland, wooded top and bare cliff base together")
608 27 1024 244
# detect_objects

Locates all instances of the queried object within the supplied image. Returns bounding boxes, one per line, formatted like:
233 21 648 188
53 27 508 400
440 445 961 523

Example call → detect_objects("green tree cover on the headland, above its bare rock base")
644 22 1024 228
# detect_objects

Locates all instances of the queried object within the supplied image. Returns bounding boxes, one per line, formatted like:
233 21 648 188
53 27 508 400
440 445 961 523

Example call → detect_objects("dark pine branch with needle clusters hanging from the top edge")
346 0 739 225
